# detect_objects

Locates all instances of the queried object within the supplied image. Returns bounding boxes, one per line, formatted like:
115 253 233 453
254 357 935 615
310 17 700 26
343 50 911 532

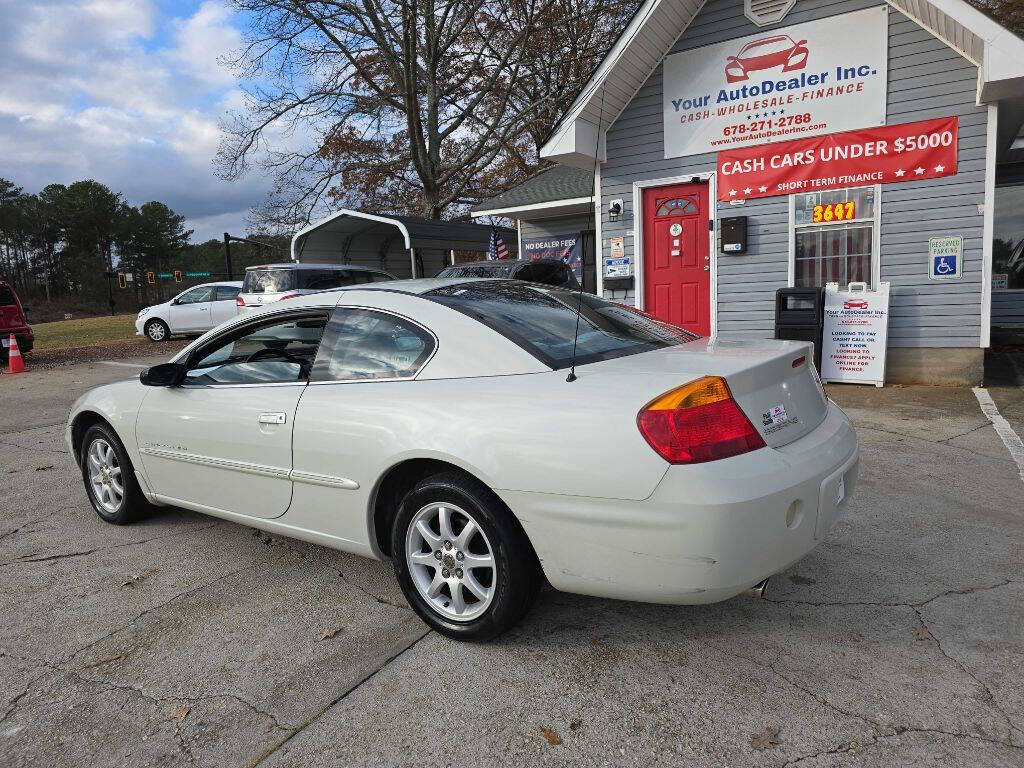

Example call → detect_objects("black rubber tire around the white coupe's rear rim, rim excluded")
391 472 543 640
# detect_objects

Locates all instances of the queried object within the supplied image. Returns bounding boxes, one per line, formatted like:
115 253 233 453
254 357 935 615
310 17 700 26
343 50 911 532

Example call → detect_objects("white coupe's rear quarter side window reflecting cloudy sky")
311 308 434 381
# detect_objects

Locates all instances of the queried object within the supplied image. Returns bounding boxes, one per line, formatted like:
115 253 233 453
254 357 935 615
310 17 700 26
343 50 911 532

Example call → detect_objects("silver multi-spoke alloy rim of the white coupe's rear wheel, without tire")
406 502 497 622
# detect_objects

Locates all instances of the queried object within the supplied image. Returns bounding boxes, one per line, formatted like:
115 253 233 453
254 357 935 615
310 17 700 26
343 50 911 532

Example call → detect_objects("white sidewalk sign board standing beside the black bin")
821 283 889 387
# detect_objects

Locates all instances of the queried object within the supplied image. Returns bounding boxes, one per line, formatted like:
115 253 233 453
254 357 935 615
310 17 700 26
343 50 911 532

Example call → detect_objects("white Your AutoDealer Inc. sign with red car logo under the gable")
663 6 889 158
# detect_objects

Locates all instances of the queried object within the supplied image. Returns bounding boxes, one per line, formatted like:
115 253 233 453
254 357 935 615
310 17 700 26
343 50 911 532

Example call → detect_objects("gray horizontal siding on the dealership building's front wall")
601 0 987 347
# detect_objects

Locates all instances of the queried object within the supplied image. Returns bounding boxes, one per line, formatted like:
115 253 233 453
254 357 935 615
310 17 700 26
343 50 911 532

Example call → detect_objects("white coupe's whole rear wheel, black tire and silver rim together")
391 473 542 640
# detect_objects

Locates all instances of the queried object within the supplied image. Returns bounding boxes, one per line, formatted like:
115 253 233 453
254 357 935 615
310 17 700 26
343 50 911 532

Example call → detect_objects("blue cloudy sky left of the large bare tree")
0 0 268 242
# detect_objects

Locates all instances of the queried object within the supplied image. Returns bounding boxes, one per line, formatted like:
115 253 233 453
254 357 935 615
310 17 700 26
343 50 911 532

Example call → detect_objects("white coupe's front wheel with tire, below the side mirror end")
79 424 153 525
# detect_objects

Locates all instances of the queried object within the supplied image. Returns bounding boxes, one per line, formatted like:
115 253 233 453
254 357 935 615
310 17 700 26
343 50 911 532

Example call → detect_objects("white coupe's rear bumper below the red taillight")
501 403 859 603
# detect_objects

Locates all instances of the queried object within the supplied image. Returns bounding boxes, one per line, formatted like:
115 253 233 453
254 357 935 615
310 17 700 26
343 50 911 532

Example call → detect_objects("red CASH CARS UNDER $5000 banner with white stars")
718 117 957 202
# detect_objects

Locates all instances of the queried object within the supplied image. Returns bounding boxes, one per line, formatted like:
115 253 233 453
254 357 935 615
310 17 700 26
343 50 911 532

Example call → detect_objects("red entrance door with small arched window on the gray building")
643 184 711 336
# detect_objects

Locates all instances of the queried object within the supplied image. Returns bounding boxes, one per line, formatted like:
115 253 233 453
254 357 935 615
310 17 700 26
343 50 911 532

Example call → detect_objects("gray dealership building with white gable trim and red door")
473 0 1024 384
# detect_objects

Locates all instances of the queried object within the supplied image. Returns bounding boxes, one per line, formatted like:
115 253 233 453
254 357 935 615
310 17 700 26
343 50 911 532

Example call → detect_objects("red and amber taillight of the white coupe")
637 376 765 464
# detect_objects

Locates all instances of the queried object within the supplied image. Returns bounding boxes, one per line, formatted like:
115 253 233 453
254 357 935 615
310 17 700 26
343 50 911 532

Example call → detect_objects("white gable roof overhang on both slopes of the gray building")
541 0 1024 168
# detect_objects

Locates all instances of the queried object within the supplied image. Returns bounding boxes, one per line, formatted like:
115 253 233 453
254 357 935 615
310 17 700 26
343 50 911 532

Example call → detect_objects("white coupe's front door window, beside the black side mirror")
183 314 327 384
